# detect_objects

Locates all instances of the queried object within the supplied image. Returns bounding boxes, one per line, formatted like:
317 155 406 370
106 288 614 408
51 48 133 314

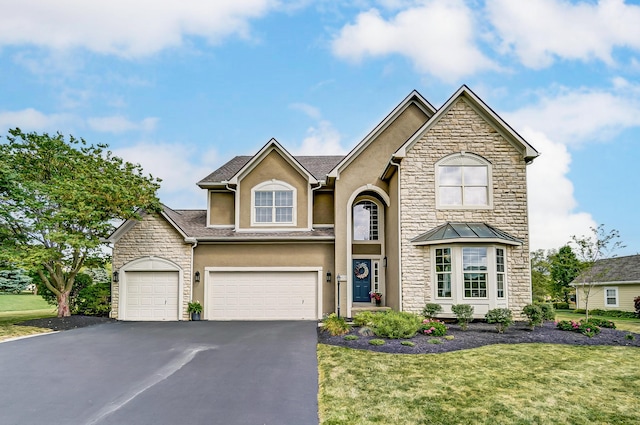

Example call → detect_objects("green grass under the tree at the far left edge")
0 294 56 341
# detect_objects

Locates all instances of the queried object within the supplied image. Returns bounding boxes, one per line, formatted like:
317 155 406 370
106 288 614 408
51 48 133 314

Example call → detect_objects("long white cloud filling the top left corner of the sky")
0 0 277 57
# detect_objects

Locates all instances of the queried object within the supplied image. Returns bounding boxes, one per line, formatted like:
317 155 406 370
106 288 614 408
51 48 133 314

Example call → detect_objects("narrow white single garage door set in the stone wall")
125 272 178 321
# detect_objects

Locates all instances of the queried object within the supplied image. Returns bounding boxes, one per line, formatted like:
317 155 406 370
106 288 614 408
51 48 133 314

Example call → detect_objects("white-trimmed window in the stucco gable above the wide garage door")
251 180 296 225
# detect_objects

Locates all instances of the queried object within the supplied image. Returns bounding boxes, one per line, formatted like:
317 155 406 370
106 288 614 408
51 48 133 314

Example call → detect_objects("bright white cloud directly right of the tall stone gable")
522 128 596 251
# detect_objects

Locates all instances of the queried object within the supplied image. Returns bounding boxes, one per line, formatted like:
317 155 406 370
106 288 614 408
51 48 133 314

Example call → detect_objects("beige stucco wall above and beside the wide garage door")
193 242 335 313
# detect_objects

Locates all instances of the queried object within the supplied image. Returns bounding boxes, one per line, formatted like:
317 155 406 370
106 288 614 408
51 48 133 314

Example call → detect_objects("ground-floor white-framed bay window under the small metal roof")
432 245 507 301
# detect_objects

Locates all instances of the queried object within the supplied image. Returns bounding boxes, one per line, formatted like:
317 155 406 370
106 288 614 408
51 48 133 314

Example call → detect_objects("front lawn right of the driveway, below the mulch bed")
318 344 640 425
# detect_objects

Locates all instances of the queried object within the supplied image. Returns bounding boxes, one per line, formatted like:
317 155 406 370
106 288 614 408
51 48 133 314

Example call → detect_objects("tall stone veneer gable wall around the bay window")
400 99 531 317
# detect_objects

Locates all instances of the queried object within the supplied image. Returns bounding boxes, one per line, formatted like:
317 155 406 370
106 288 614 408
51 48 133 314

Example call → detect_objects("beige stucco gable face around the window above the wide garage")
239 150 310 229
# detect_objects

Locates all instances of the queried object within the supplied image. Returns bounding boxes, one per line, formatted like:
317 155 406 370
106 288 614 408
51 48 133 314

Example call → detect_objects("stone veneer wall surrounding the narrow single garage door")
111 214 192 320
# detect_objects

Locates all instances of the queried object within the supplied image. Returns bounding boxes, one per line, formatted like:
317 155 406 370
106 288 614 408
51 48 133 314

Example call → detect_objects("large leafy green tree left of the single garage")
0 129 160 317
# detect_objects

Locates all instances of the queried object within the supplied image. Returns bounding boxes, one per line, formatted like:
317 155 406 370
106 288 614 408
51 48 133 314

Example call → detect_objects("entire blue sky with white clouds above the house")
0 0 640 255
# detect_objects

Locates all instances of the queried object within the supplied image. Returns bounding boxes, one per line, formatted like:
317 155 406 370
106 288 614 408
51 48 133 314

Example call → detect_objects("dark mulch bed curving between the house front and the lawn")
318 322 640 354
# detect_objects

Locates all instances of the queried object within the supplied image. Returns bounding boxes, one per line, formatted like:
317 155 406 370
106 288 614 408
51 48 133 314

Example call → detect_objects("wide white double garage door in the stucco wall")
205 271 318 320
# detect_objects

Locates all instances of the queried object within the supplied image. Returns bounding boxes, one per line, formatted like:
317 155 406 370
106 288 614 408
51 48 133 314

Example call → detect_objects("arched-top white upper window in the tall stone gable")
436 152 492 208
